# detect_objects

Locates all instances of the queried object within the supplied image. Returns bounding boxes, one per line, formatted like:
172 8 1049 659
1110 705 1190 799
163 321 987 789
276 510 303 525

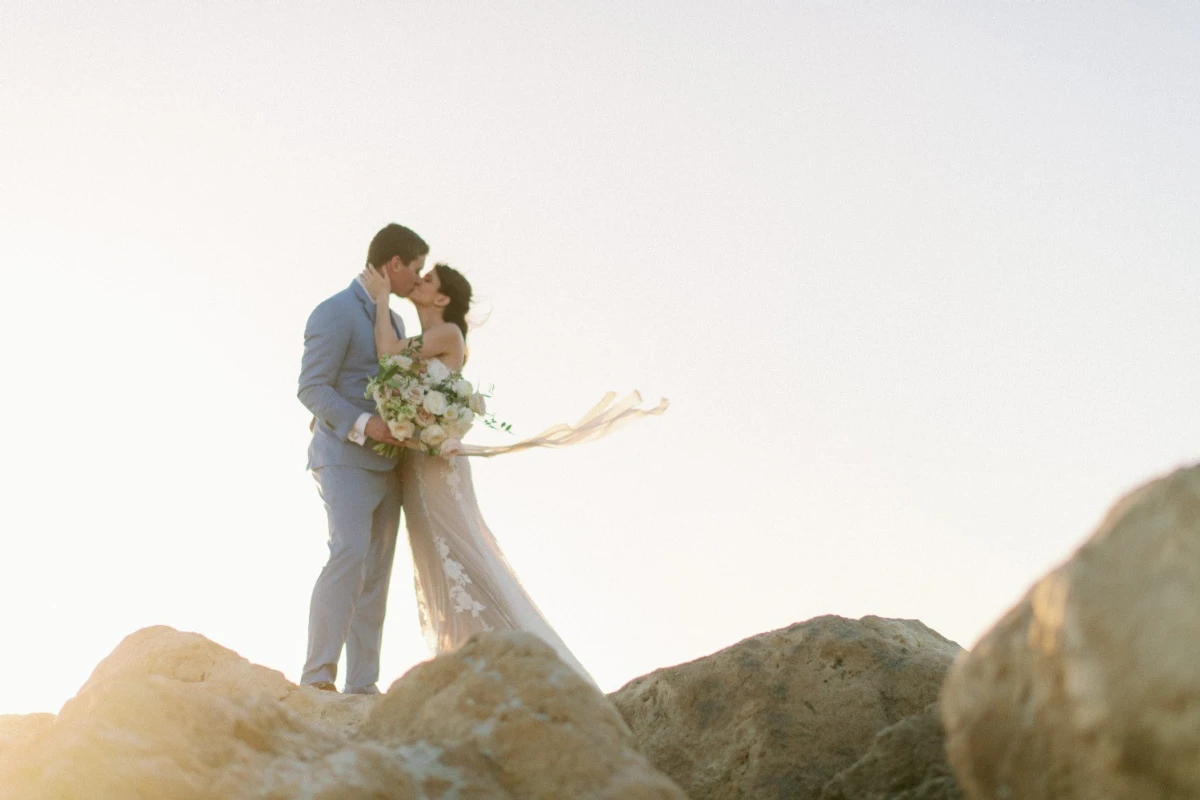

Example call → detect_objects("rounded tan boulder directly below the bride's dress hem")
355 633 686 800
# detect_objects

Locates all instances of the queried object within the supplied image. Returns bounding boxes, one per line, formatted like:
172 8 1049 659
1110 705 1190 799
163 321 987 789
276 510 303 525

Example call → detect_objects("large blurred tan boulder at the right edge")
942 467 1200 800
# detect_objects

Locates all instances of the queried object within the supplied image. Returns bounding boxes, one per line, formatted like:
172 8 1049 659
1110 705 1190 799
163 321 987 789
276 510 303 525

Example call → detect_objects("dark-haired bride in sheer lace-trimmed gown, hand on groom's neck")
360 264 595 685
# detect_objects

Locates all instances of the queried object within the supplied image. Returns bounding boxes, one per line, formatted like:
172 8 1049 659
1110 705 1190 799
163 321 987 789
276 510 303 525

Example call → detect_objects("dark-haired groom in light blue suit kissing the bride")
298 223 430 694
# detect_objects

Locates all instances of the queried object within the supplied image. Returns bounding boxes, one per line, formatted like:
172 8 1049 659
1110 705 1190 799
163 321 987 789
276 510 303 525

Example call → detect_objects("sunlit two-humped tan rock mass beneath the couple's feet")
0 627 686 800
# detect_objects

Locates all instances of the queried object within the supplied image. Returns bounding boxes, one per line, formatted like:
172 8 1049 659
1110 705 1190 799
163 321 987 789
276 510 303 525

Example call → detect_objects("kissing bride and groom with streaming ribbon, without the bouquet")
298 223 666 694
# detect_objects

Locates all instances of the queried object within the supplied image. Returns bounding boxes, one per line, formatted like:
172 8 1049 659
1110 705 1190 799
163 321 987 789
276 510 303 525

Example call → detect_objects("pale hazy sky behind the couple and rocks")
0 0 1200 714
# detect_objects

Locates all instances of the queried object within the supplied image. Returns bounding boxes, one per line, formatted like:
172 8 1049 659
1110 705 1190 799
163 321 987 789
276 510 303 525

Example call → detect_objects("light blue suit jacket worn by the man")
296 281 404 470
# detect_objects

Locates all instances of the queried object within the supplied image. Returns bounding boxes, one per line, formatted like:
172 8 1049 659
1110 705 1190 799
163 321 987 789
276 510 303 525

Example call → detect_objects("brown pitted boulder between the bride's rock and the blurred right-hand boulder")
611 616 960 800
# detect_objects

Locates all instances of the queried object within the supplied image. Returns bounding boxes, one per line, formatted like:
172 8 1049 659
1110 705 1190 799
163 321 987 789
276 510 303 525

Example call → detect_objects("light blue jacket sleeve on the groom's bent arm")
296 303 362 439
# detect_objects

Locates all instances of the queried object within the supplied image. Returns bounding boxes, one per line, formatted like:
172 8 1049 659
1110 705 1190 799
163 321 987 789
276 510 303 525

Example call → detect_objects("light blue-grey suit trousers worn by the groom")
300 467 401 692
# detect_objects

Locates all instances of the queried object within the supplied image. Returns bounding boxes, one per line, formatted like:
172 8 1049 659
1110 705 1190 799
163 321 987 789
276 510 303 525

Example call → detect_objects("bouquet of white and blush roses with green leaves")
365 337 512 457
